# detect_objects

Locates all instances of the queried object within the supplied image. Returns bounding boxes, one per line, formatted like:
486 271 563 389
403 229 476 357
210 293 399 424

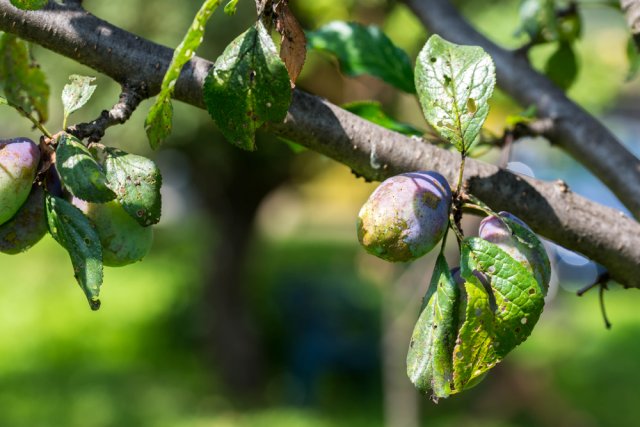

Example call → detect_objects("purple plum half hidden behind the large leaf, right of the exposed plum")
479 212 551 294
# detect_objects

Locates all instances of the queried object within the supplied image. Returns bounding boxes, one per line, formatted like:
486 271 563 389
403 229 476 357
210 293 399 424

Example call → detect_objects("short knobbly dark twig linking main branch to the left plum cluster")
66 83 146 142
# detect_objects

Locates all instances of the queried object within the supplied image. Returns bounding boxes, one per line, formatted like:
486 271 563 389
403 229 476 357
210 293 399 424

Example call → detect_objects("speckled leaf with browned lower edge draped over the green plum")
104 148 162 227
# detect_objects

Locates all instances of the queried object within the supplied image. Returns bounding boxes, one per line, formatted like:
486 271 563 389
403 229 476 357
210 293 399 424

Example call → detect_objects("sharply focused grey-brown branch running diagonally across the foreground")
0 0 640 287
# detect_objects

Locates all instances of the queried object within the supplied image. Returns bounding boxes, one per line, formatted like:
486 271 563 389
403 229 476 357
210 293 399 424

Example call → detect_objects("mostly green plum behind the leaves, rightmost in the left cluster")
72 197 153 267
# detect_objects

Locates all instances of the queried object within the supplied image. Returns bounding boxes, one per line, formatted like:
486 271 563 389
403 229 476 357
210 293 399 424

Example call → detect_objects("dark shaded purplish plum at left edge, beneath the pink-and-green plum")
0 184 47 255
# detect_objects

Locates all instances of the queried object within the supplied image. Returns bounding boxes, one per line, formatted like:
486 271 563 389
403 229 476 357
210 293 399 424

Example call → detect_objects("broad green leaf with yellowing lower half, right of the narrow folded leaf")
452 237 544 393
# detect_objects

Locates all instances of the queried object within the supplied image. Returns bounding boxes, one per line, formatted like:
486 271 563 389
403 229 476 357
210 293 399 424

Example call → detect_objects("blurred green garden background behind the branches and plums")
0 0 640 427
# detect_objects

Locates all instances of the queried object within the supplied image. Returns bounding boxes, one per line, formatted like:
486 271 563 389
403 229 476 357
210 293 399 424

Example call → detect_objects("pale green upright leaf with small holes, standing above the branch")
416 35 496 153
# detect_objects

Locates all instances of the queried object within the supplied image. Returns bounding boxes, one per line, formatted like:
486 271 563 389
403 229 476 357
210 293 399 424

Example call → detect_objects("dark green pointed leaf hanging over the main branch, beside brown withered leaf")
204 22 291 150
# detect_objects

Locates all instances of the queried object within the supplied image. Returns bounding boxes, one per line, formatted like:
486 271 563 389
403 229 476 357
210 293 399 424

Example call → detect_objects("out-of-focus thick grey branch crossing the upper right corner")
405 0 640 218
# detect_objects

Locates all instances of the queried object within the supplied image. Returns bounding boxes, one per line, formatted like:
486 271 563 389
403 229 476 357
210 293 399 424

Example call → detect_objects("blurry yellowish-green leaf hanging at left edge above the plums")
0 33 49 123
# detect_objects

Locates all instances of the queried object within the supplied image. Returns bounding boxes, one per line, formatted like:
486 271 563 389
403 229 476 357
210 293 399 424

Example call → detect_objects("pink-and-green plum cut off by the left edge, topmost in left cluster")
0 138 40 224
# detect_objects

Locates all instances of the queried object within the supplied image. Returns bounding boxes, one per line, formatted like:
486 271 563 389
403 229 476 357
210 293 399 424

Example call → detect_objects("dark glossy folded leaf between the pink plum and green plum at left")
56 134 116 203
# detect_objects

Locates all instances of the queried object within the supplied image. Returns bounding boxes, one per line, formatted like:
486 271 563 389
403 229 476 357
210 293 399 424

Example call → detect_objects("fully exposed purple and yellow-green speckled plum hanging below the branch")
357 171 451 262
